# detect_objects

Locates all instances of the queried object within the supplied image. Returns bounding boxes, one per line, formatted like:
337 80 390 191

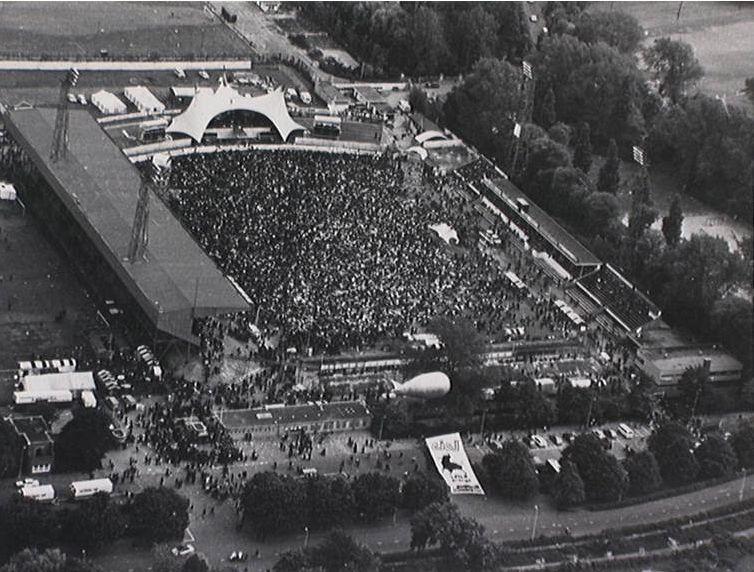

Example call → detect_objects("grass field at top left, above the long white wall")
0 2 250 59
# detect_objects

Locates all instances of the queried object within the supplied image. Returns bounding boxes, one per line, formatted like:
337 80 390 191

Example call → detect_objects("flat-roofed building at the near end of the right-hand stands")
636 346 743 387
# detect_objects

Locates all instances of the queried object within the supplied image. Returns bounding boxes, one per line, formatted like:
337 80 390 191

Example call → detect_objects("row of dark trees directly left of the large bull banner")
242 472 448 539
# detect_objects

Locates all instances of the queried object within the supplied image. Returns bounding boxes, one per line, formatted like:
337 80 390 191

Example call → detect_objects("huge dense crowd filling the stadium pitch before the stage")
170 150 536 352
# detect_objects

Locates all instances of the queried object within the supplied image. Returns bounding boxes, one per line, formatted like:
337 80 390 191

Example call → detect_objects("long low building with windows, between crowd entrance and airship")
218 401 372 440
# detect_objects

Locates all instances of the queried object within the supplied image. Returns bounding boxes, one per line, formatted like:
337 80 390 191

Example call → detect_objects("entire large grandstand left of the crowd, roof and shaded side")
4 108 249 344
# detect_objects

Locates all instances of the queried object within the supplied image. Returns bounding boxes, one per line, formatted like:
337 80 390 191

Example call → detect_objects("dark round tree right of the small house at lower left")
55 408 115 473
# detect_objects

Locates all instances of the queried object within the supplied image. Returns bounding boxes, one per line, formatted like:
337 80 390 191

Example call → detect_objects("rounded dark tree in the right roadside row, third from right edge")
647 421 699 486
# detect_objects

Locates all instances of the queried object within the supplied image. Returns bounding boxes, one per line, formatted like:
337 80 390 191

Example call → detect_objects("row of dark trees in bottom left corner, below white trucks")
0 488 189 560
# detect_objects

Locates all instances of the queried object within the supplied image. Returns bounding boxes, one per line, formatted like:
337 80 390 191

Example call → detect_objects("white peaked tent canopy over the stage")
167 84 304 143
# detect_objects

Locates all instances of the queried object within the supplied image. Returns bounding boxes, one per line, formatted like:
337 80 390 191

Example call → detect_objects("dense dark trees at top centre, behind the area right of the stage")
298 2 531 77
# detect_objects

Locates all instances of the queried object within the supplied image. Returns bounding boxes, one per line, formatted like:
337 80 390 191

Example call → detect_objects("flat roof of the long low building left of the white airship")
217 401 369 427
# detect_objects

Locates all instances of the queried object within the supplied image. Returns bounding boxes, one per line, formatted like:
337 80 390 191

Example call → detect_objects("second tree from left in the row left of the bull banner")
305 475 353 529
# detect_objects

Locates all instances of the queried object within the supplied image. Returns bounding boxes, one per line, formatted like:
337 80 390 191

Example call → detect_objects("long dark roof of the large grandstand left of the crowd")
6 109 248 340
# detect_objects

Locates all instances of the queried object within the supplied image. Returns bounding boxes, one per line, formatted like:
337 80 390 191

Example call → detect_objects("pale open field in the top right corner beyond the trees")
591 2 754 105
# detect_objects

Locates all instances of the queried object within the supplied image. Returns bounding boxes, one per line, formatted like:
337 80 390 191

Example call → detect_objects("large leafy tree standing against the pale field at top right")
644 38 704 103
